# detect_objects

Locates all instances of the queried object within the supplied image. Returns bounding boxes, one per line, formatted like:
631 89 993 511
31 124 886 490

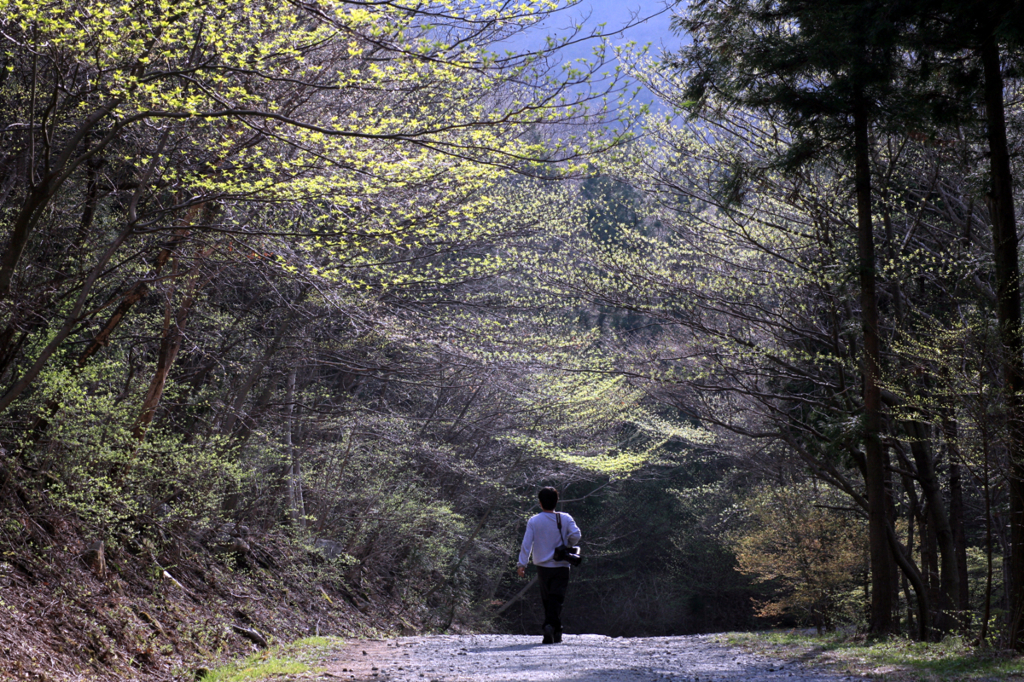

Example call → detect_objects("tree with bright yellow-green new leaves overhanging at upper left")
0 1 630 410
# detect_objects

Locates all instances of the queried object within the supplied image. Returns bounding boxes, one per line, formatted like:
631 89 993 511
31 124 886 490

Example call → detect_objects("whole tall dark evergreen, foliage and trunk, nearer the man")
675 0 925 634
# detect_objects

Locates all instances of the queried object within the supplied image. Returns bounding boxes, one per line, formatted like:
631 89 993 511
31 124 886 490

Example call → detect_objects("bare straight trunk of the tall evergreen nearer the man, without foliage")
854 94 893 635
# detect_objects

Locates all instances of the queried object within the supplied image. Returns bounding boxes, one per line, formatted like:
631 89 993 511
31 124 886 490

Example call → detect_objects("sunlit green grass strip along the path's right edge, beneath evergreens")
720 631 1024 682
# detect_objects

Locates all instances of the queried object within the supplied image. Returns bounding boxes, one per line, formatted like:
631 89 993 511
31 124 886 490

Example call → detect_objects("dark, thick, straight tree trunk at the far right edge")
980 32 1024 650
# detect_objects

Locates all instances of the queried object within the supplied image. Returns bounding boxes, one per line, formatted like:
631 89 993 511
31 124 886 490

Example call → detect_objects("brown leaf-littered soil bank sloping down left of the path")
0 518 416 682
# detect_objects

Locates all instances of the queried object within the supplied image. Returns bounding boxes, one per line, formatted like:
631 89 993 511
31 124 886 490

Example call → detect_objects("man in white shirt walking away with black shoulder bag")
516 487 583 644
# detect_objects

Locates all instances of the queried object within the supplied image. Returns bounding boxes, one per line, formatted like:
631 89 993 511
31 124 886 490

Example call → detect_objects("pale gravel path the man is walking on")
328 635 854 682
